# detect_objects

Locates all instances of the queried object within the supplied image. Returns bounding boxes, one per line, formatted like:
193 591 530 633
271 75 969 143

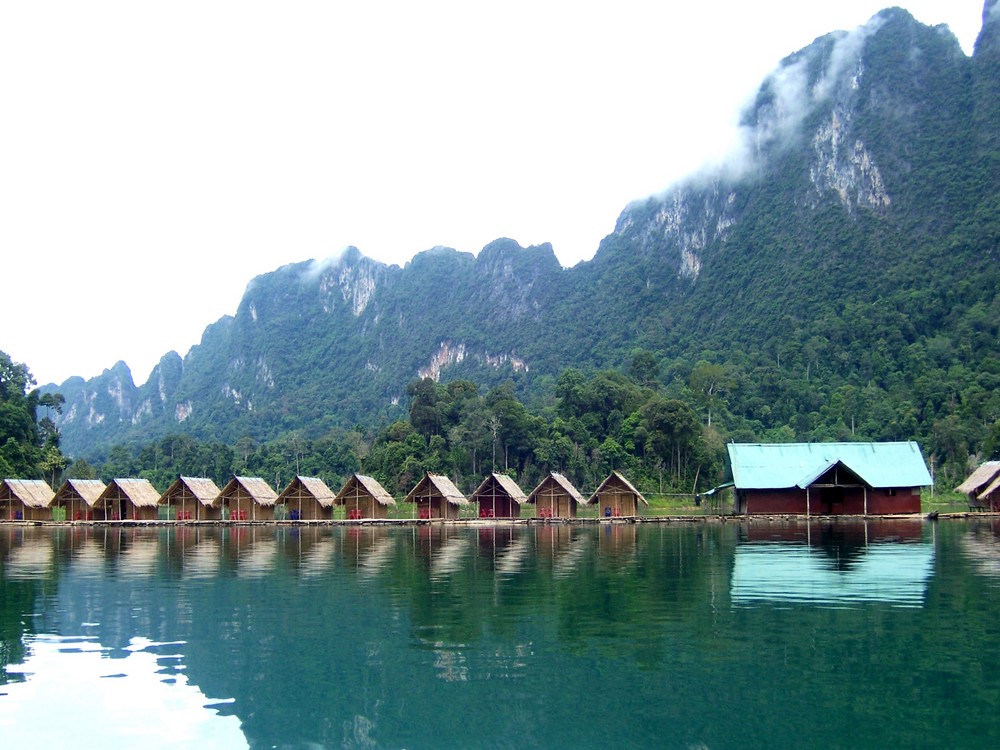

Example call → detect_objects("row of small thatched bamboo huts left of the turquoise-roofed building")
0 471 649 523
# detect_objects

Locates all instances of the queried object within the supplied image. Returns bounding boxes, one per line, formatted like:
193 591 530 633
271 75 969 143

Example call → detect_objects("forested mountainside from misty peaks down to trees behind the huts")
31 0 1000 491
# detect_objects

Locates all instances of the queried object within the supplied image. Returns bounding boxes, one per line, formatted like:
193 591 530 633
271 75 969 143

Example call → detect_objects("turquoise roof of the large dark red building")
728 441 931 489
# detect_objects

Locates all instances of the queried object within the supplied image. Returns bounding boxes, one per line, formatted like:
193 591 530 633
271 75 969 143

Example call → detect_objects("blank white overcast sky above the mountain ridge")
0 0 983 385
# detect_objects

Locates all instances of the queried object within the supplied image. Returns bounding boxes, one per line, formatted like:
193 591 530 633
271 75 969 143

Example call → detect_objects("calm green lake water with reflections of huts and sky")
0 520 1000 750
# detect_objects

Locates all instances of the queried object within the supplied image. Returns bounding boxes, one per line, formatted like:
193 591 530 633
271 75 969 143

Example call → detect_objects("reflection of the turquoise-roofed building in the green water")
730 524 934 607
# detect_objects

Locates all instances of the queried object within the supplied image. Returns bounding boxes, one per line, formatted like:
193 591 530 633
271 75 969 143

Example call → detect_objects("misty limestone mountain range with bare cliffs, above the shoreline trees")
49 5 1000 462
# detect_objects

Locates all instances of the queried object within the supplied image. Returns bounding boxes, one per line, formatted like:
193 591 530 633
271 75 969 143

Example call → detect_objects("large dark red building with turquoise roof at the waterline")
727 442 931 515
